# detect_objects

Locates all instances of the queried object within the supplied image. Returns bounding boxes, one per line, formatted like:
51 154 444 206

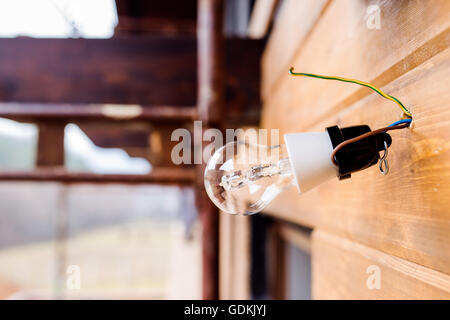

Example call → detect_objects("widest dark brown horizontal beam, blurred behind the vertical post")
0 36 264 123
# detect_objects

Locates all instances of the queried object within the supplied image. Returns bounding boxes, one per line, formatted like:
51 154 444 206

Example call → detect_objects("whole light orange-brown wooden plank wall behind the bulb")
261 0 450 299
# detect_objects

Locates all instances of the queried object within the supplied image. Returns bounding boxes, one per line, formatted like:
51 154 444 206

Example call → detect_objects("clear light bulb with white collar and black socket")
204 125 392 215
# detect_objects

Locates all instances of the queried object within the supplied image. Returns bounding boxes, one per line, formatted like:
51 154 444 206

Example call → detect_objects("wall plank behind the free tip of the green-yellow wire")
263 0 450 133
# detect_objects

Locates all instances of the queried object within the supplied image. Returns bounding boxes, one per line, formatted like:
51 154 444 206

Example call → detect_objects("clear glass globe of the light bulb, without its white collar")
204 141 295 215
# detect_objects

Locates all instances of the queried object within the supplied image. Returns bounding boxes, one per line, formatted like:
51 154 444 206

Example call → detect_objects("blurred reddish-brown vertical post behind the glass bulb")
195 0 224 299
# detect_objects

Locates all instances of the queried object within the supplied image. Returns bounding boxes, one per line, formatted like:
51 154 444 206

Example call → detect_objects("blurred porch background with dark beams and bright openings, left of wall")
0 0 267 299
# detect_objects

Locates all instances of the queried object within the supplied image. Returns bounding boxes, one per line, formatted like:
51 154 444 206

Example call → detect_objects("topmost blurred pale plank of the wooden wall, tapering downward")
261 0 330 99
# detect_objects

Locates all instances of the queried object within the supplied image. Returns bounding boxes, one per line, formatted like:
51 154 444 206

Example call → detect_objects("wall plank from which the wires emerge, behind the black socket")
267 49 450 274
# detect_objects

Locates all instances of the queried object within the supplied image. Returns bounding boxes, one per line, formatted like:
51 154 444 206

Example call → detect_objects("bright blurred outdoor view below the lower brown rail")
0 183 201 299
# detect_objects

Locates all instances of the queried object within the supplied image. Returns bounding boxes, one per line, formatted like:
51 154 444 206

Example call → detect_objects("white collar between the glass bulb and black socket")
284 132 339 193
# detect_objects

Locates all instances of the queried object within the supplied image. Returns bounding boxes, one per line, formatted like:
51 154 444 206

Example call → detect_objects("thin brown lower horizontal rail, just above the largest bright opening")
0 168 195 185
